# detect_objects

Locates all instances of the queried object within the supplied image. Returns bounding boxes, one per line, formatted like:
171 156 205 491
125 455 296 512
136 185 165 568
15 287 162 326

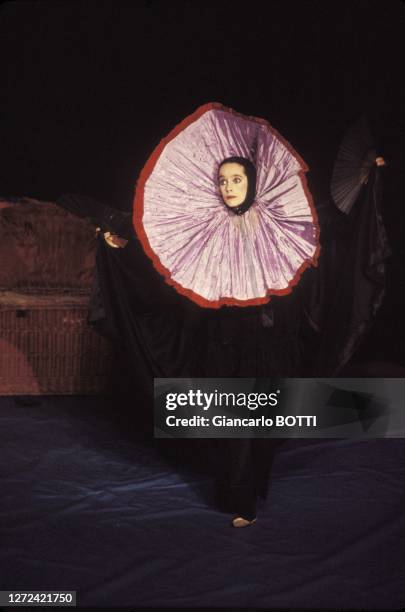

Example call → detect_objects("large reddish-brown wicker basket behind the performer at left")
0 201 112 395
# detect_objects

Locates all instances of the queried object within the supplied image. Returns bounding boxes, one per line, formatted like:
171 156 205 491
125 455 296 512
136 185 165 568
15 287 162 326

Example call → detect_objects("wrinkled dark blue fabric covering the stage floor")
0 397 405 610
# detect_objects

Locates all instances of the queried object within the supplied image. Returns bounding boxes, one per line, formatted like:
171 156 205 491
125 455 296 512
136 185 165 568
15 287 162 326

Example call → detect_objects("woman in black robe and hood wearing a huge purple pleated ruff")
58 104 383 527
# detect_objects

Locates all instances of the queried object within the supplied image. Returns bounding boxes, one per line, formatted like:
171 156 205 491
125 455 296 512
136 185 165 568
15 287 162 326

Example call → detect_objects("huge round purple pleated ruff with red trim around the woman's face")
135 104 318 306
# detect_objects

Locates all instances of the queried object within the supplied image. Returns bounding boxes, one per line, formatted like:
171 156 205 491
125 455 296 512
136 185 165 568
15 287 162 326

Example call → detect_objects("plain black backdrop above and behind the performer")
0 0 405 362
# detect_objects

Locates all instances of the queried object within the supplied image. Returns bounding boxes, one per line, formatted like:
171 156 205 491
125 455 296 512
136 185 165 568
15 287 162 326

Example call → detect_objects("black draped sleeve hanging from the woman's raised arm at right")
302 166 391 377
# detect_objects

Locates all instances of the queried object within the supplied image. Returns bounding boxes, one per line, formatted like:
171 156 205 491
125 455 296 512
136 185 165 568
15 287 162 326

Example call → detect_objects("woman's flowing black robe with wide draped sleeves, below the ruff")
55 168 389 519
